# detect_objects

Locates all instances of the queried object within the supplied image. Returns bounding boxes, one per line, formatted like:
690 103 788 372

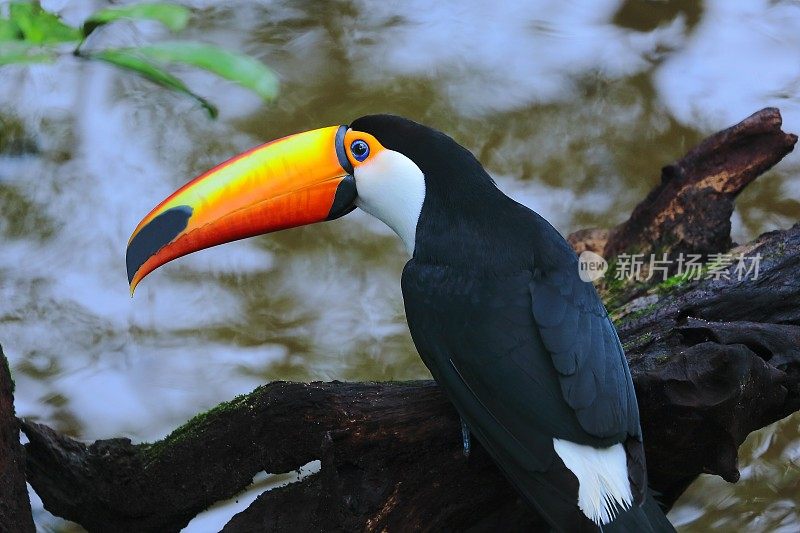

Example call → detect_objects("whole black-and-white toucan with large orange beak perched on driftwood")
127 115 674 532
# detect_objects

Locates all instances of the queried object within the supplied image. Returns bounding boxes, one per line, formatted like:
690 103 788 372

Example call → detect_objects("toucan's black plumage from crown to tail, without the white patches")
351 115 671 531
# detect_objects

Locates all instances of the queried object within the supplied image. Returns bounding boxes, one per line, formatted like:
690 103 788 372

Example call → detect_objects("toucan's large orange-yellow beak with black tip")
126 126 356 294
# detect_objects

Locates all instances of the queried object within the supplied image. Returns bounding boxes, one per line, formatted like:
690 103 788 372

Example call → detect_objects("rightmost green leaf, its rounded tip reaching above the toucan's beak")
135 41 278 101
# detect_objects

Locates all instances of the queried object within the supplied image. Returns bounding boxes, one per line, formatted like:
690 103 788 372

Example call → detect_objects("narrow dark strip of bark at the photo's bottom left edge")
0 346 34 532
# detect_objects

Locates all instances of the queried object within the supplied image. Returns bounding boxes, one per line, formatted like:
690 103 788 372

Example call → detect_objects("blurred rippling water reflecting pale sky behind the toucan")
0 0 800 531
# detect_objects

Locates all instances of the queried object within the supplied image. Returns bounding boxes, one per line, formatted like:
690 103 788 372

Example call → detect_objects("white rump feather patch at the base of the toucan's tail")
553 439 633 526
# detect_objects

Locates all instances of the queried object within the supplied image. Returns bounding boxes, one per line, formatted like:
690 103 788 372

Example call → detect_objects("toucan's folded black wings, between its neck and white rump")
403 254 644 500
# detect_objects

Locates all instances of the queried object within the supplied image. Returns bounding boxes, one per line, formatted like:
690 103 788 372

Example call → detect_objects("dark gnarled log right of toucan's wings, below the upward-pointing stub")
618 225 800 501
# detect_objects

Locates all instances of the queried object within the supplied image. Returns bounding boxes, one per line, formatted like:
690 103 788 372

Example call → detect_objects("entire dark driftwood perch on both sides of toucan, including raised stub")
7 109 800 532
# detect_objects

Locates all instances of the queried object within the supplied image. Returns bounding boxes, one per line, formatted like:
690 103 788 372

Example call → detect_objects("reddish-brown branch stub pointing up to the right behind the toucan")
569 107 797 257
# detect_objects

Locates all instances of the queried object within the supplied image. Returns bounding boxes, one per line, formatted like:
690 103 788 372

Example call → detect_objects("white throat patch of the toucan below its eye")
353 149 425 255
